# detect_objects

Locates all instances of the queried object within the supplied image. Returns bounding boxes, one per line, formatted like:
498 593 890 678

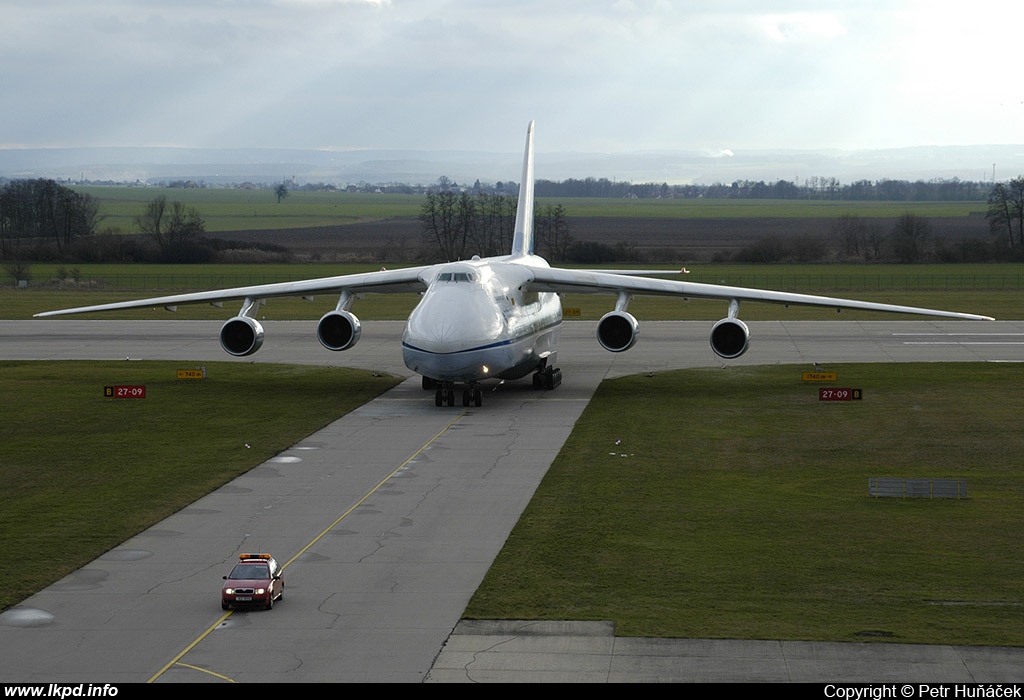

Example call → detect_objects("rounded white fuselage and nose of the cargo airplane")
401 256 562 384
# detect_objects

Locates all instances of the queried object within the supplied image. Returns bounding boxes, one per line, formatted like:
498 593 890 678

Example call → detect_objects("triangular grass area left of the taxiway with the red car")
0 362 397 610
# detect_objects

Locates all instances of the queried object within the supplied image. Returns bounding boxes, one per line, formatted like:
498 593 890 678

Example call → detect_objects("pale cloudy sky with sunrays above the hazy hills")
0 0 1024 154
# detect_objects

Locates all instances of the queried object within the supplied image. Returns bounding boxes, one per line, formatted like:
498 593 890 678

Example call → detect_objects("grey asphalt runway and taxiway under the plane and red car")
0 319 1024 683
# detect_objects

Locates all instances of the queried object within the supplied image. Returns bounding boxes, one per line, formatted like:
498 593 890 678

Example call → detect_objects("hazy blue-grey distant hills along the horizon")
0 145 1024 185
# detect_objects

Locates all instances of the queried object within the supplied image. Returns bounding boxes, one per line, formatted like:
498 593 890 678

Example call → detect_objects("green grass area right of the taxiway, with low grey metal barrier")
466 364 1024 646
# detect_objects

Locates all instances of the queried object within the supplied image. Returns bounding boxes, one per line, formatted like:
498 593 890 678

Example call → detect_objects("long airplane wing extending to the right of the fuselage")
524 267 993 320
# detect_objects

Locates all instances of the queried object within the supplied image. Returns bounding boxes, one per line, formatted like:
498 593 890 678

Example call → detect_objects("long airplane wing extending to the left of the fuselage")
35 265 431 317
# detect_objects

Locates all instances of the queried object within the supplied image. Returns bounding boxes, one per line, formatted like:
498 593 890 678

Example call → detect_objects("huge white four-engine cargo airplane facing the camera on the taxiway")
35 122 993 406
